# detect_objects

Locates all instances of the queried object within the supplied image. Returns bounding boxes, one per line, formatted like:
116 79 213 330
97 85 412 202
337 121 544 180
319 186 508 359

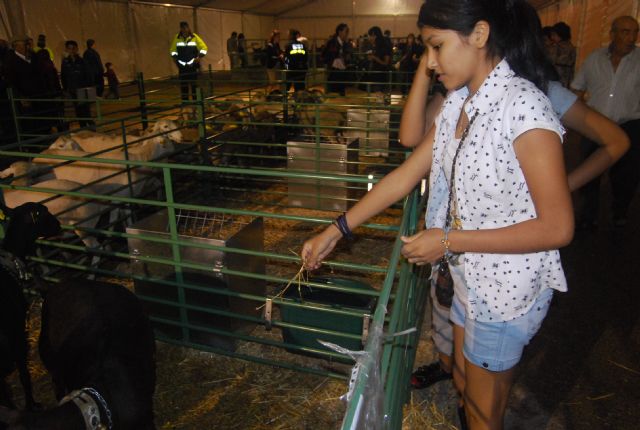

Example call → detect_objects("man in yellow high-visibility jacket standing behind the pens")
170 21 207 101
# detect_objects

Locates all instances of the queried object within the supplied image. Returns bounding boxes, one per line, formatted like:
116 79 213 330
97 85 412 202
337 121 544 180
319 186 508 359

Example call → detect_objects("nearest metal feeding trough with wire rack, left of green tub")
127 209 265 351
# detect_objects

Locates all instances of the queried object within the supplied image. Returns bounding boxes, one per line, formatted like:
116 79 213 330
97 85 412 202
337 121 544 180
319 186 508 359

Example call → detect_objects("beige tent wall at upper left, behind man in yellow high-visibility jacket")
8 0 275 80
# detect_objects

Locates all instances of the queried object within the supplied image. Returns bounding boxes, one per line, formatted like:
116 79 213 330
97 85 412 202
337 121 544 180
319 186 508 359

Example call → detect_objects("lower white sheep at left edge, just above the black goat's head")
0 161 105 265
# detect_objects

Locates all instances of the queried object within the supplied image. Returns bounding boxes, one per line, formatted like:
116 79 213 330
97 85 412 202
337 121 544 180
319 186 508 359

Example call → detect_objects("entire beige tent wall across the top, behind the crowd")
0 0 640 80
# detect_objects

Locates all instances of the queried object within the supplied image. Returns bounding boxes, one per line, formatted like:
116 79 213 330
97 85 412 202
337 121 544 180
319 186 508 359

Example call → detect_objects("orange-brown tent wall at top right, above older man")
538 0 640 68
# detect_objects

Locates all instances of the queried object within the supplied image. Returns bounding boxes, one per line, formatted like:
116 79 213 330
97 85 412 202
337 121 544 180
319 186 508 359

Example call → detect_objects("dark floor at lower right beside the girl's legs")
509 195 640 429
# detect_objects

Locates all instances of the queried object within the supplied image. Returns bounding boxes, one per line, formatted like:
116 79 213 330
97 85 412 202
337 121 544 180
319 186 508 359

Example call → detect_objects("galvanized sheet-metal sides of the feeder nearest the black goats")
127 210 265 351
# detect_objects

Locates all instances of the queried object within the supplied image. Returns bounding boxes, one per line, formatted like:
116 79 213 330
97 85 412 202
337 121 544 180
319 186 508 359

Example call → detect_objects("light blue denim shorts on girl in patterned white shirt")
449 282 553 372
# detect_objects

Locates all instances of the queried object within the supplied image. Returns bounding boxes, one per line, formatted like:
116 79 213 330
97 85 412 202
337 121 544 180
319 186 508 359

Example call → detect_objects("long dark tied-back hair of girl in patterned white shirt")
418 0 557 92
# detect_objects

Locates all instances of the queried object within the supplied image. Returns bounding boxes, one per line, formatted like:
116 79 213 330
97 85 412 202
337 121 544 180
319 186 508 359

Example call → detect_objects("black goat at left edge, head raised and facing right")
0 203 60 410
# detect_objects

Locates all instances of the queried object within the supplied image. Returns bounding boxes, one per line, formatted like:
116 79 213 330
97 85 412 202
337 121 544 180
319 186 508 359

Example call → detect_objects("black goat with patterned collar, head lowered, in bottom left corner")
0 280 156 430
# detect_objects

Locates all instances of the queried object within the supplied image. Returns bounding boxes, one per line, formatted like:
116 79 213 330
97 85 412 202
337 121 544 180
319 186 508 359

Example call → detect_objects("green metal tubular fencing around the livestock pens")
0 69 426 429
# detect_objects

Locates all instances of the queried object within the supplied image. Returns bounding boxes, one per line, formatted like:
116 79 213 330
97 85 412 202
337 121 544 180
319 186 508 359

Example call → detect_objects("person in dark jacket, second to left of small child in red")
60 40 95 127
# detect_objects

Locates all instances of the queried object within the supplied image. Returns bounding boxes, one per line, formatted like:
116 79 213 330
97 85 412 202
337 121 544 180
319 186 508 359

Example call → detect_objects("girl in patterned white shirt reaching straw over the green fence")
302 0 573 429
